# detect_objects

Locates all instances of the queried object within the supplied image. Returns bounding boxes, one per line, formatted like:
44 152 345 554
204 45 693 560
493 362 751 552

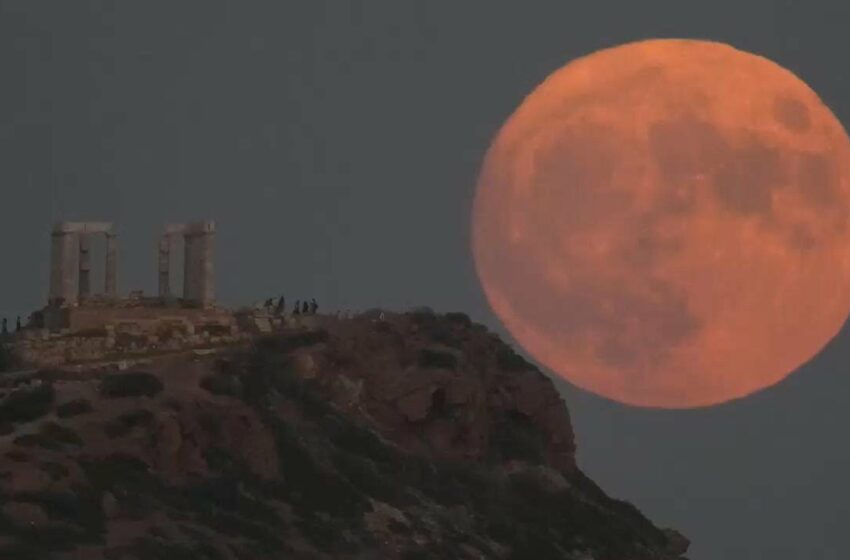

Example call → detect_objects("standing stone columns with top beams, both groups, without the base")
49 221 215 307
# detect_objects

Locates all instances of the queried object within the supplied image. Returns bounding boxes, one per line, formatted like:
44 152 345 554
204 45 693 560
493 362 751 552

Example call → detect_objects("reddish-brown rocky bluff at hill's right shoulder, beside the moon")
294 313 575 471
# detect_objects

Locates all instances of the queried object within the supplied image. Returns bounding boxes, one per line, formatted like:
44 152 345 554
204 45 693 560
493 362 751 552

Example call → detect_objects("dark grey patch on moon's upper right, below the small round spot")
714 140 785 218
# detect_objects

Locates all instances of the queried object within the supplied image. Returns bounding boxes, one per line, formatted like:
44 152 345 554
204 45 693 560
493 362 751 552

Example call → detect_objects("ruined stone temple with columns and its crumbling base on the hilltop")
1 221 331 371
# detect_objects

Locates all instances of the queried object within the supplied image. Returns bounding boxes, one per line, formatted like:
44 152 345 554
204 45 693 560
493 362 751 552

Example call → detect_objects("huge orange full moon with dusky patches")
471 39 850 408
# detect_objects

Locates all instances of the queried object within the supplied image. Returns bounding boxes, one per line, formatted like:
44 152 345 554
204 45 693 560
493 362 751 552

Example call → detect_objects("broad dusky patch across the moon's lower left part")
488 241 702 367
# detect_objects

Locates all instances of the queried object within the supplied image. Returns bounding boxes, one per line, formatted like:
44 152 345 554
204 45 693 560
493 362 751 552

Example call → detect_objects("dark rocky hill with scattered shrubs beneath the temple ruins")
0 311 687 560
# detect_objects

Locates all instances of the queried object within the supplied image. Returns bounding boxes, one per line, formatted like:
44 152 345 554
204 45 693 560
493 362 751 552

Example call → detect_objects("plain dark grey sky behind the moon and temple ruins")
0 0 850 560
